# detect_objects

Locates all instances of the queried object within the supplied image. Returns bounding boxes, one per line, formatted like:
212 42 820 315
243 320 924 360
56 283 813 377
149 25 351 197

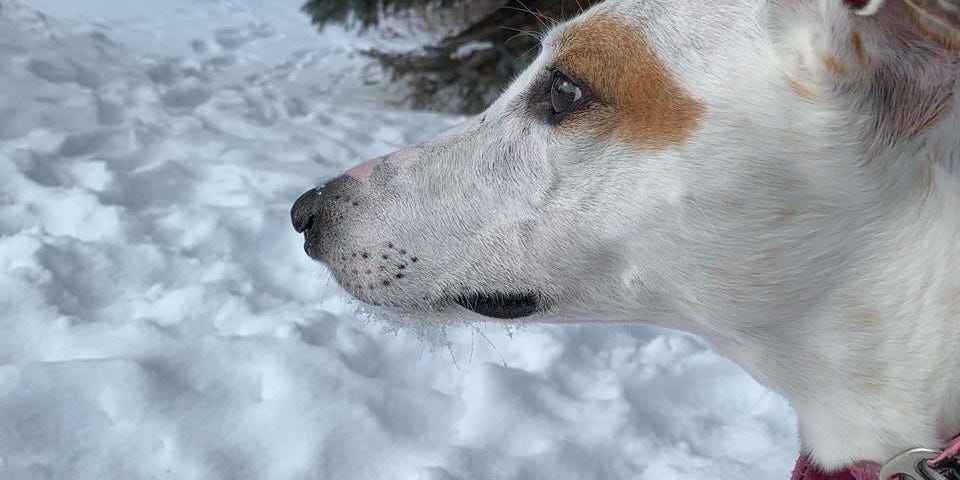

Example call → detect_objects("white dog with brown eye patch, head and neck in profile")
291 0 960 480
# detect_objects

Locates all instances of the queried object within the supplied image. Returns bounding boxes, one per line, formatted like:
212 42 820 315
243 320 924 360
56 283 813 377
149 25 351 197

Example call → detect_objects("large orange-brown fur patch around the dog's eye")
554 15 706 148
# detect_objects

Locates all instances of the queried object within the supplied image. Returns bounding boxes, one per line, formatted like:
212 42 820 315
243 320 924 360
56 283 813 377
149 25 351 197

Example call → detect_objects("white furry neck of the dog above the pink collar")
717 150 960 469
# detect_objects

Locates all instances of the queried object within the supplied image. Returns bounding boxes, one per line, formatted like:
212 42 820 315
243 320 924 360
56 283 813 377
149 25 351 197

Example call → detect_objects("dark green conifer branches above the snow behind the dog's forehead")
303 0 600 113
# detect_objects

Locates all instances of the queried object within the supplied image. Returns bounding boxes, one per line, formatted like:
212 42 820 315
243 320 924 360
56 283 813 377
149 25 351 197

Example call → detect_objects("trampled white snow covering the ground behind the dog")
0 0 797 480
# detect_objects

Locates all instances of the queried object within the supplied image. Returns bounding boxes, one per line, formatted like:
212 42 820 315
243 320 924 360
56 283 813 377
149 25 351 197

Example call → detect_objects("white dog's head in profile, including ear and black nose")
292 0 957 333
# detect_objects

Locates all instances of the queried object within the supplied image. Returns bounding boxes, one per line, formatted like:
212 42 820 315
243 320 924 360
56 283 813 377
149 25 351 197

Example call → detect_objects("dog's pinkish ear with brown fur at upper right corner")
768 0 960 152
